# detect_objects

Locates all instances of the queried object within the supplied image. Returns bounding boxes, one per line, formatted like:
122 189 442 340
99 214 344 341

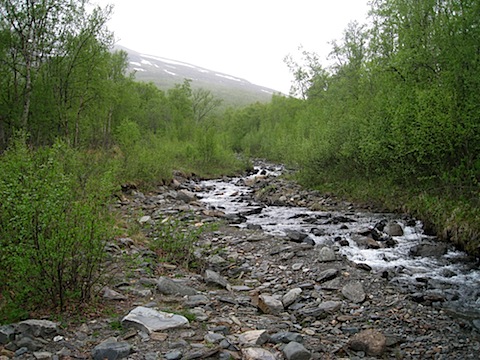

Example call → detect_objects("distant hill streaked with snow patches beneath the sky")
116 46 279 106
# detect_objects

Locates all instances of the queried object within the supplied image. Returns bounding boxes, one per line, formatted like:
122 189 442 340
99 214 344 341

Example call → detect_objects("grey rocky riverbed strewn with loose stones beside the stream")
0 165 480 360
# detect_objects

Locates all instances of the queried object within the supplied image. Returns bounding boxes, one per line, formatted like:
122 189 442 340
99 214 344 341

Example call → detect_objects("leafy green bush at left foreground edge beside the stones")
0 137 113 321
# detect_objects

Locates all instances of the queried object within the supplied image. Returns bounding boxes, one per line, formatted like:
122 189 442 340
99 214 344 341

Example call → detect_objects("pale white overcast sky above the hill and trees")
93 0 368 93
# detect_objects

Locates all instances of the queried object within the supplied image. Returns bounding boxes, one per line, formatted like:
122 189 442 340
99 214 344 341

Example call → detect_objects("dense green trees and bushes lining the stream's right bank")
222 0 480 253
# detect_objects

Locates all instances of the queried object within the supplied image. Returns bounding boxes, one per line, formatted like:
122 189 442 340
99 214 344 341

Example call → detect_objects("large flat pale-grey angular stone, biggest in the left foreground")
122 306 189 334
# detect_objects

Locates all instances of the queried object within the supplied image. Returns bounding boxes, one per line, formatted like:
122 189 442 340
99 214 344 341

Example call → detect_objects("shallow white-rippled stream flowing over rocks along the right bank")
198 166 480 322
